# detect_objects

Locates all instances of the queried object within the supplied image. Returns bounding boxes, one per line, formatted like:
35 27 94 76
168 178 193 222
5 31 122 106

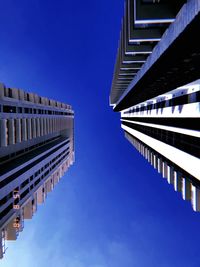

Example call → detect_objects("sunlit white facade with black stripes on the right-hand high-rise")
121 80 200 211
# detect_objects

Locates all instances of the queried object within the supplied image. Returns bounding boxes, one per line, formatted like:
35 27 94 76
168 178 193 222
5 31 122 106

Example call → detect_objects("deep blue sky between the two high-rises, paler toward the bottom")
0 0 200 267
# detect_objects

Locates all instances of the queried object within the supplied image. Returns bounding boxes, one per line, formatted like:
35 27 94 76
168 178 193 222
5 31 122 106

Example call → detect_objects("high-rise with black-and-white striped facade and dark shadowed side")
110 0 200 211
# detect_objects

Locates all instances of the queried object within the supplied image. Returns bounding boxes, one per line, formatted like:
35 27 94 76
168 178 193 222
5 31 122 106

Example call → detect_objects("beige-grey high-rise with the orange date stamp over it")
0 84 74 258
